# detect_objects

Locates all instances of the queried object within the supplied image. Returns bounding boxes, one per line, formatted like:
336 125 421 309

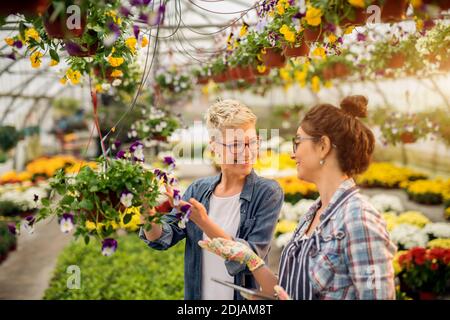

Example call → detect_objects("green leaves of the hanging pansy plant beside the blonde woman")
37 158 160 238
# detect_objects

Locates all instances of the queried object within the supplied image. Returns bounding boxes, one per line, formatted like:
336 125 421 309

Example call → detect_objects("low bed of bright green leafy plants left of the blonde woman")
44 234 184 300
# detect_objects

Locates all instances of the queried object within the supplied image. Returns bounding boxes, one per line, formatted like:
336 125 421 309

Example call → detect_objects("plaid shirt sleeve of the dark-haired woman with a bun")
344 204 396 300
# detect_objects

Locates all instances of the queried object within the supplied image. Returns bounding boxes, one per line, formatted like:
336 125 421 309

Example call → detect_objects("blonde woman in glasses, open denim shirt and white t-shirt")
140 100 283 300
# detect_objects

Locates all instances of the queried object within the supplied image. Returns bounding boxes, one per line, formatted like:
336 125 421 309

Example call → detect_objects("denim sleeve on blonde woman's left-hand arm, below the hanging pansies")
139 184 194 250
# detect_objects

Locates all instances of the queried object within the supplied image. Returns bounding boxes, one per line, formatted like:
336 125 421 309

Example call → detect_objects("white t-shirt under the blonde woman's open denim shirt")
202 193 241 300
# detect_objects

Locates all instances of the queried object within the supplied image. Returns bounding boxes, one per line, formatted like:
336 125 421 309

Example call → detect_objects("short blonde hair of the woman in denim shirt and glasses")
205 99 257 136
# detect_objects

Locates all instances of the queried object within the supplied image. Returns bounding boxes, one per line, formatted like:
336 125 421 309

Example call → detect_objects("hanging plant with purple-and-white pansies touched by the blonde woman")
36 150 183 255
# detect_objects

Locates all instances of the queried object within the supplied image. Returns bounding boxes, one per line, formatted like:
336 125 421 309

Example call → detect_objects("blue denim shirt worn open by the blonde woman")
139 170 284 300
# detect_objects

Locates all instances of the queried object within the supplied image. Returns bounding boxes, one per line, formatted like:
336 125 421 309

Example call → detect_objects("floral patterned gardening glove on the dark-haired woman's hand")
198 238 264 271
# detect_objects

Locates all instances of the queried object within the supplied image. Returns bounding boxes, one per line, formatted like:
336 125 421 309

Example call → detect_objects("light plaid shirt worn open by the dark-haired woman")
280 179 396 300
